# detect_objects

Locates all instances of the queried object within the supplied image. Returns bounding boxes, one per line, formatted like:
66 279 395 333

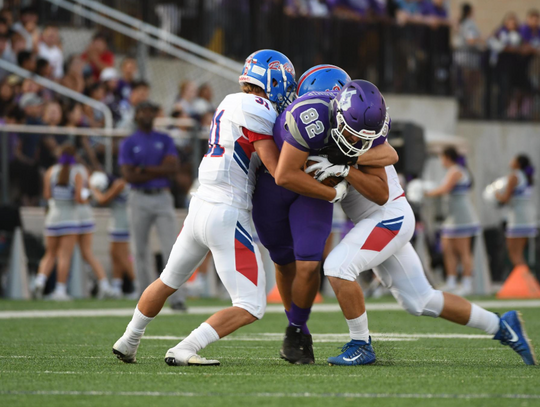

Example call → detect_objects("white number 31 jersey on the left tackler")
195 93 277 210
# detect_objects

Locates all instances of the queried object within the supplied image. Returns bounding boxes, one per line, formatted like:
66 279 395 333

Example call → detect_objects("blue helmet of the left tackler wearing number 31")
238 49 296 113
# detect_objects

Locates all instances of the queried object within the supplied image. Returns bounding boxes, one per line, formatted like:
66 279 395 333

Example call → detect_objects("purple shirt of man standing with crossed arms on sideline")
119 130 178 189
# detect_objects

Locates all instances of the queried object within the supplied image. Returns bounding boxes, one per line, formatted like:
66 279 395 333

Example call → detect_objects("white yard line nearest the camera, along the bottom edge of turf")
0 390 540 399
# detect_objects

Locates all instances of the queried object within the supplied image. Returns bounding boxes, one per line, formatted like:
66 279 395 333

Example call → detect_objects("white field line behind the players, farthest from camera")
0 300 540 319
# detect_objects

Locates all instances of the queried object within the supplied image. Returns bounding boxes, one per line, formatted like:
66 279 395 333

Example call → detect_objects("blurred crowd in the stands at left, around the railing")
0 8 214 206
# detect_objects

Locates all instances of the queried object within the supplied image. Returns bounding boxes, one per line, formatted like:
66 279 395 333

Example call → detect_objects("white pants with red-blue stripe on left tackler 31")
160 197 266 319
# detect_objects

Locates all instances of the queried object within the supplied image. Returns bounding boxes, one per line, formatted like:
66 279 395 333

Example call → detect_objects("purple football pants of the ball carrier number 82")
253 170 333 266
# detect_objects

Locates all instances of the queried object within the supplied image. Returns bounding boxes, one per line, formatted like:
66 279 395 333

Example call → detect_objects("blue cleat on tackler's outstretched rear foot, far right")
493 311 536 365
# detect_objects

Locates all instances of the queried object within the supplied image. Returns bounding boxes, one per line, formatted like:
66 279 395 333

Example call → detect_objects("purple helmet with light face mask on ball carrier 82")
332 79 390 157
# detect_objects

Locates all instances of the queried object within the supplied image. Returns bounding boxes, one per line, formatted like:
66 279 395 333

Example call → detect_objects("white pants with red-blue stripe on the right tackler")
324 197 440 316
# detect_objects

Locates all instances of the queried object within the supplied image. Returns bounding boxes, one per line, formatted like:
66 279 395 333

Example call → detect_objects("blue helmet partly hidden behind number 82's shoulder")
296 65 351 97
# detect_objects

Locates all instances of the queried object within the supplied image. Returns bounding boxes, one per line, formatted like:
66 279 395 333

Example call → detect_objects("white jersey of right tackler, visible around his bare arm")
341 165 404 224
